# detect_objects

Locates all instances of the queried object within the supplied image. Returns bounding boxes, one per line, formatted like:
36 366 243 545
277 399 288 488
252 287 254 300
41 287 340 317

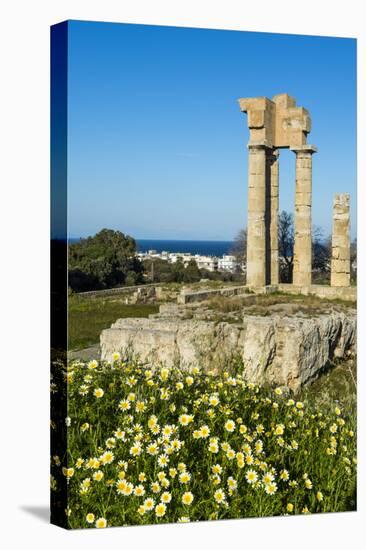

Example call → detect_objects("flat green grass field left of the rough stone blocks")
69 296 159 350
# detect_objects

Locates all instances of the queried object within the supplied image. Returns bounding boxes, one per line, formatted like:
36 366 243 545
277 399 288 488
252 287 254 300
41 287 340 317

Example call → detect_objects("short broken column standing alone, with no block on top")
330 193 351 286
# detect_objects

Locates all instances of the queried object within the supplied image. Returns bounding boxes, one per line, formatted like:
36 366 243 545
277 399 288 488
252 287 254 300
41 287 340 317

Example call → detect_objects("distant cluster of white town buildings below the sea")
136 249 244 273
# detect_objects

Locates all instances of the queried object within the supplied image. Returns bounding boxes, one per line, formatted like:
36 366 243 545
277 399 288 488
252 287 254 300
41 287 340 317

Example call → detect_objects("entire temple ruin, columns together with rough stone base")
100 94 356 391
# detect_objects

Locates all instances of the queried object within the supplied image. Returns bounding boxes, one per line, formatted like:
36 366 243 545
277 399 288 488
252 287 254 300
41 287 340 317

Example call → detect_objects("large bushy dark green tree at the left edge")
69 229 143 291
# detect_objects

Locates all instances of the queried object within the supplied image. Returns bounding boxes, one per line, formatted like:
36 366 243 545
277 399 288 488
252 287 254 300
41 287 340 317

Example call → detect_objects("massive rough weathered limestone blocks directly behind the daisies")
100 310 356 391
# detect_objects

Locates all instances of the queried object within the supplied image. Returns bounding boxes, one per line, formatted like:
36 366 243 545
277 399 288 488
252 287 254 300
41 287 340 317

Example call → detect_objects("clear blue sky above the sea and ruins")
68 21 356 240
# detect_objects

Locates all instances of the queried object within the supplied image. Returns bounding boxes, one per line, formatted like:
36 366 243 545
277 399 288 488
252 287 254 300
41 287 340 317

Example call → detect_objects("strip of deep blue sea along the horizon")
69 237 234 257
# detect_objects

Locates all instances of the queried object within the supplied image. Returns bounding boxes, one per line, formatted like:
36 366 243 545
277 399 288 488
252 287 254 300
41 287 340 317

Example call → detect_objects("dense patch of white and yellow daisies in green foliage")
51 354 356 528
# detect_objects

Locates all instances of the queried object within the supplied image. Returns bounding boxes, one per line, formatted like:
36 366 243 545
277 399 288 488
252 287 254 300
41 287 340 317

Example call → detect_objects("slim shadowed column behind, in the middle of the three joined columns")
269 149 279 285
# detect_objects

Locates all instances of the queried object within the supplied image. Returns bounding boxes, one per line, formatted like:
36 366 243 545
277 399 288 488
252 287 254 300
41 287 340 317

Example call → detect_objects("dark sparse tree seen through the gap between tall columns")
278 210 294 283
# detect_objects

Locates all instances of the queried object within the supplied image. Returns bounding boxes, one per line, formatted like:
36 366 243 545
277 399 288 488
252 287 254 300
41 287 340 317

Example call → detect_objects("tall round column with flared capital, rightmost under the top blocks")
291 145 317 286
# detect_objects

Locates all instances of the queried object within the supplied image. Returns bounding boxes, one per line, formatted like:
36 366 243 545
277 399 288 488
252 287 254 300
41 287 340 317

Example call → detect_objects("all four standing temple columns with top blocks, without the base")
239 94 350 294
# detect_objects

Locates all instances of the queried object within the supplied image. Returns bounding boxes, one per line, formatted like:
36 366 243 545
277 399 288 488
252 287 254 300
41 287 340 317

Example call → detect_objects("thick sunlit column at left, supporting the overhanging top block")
247 144 266 286
